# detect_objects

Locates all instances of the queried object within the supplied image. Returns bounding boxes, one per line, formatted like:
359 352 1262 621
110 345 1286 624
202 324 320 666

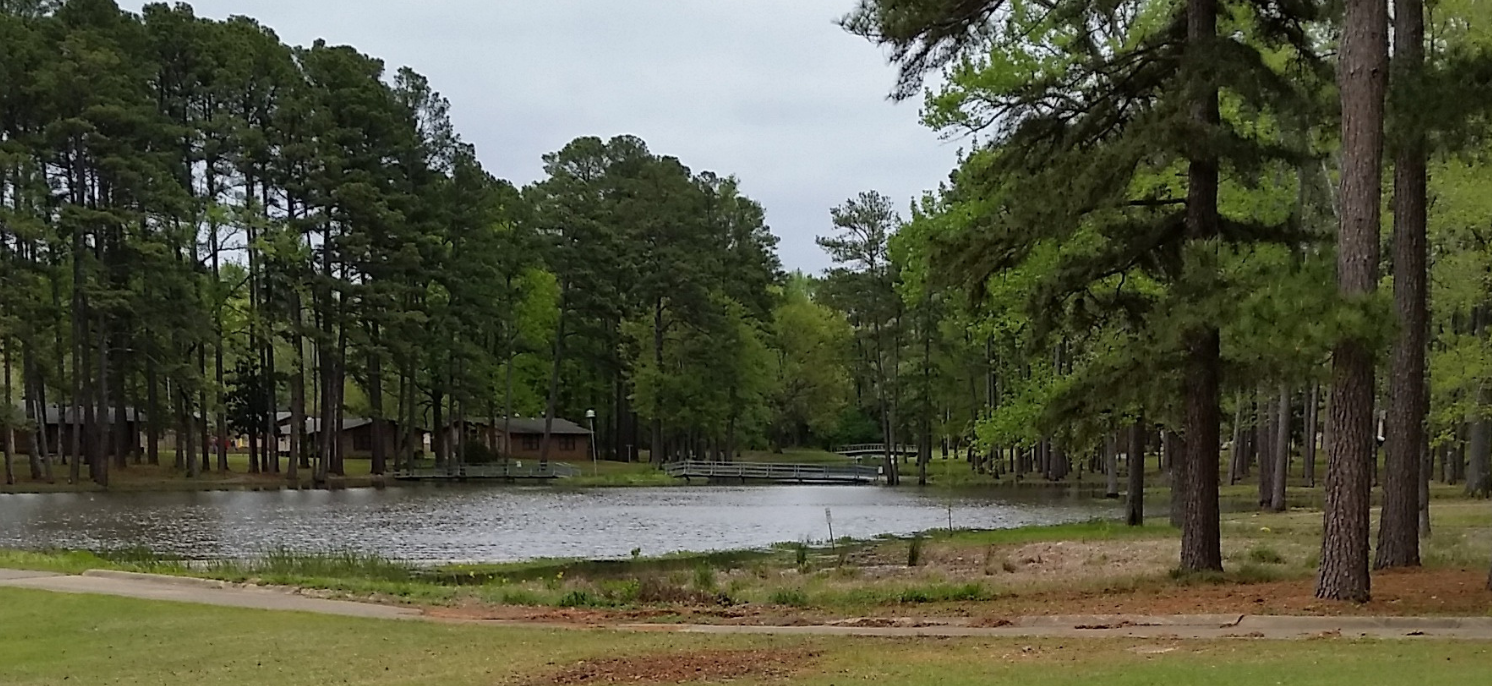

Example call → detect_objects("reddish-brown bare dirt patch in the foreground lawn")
533 650 818 686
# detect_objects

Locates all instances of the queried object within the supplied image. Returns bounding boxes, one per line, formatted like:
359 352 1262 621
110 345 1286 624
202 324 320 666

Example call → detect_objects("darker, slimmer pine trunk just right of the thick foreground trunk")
1374 0 1429 570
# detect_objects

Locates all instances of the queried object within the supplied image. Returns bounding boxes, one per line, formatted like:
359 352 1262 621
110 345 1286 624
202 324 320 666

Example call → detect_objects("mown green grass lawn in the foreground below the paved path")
0 589 1492 686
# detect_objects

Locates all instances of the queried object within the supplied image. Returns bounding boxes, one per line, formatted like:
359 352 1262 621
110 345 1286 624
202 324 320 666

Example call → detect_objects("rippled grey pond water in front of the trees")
0 486 1119 562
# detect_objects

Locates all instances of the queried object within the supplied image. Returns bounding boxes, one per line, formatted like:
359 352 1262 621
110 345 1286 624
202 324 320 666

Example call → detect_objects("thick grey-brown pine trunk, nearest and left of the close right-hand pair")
1316 0 1388 602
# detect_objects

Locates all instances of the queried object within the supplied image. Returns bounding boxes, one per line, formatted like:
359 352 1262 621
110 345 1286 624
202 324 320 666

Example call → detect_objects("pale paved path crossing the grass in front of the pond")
0 570 1492 641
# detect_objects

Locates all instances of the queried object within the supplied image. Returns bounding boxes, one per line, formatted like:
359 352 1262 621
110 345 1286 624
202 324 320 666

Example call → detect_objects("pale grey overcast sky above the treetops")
134 0 956 271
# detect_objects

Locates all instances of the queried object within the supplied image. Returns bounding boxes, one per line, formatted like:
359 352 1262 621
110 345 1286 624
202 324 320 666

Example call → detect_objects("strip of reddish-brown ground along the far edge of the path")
427 570 1492 626
